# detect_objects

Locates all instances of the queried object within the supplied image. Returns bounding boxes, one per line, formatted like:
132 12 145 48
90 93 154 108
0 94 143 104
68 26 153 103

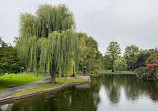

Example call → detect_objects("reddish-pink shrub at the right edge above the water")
147 59 158 75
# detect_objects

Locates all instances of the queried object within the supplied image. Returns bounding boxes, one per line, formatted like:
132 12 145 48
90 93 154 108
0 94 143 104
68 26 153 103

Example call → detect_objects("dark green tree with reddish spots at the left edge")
0 39 24 75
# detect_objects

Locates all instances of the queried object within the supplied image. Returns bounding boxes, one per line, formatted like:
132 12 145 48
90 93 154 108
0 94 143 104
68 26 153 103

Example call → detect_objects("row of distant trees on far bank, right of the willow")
102 41 156 72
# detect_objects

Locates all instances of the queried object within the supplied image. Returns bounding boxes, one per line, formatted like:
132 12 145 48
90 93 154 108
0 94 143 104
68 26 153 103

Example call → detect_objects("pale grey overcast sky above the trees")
0 0 158 54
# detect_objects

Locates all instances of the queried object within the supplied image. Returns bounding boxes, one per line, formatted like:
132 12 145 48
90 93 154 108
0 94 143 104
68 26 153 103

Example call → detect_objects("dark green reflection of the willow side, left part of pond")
10 78 100 111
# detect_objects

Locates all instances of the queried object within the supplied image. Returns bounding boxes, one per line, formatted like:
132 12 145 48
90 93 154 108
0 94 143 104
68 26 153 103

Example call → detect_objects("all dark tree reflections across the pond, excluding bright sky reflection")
3 75 158 111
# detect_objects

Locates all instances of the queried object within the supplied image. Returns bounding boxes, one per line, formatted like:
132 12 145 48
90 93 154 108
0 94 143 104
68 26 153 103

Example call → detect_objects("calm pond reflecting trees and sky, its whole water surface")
0 75 158 111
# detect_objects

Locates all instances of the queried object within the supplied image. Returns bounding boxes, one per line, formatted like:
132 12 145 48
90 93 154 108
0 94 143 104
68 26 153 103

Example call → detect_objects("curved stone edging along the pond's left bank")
0 81 90 105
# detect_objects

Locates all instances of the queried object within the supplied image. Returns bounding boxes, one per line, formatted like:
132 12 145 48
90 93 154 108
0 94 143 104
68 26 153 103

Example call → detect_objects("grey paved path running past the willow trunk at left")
0 77 50 99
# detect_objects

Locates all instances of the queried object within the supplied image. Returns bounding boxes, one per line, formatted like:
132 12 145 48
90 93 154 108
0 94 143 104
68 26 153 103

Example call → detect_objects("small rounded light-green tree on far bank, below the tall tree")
114 58 127 71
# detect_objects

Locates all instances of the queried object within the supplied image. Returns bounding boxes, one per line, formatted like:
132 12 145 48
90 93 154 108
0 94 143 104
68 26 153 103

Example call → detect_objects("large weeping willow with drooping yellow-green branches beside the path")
16 5 81 82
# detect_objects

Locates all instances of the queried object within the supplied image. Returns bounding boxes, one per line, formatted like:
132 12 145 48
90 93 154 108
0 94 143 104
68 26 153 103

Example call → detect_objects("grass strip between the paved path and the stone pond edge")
11 78 85 96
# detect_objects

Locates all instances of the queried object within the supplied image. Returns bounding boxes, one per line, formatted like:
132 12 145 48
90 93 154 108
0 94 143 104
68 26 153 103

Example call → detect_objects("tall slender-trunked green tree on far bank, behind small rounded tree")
106 41 121 72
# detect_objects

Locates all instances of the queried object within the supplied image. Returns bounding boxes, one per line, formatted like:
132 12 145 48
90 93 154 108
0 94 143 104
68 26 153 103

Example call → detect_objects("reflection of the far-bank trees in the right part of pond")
103 75 158 103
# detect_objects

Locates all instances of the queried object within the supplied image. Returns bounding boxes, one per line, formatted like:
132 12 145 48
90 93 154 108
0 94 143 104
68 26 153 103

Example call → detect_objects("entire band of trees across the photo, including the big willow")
0 4 157 80
